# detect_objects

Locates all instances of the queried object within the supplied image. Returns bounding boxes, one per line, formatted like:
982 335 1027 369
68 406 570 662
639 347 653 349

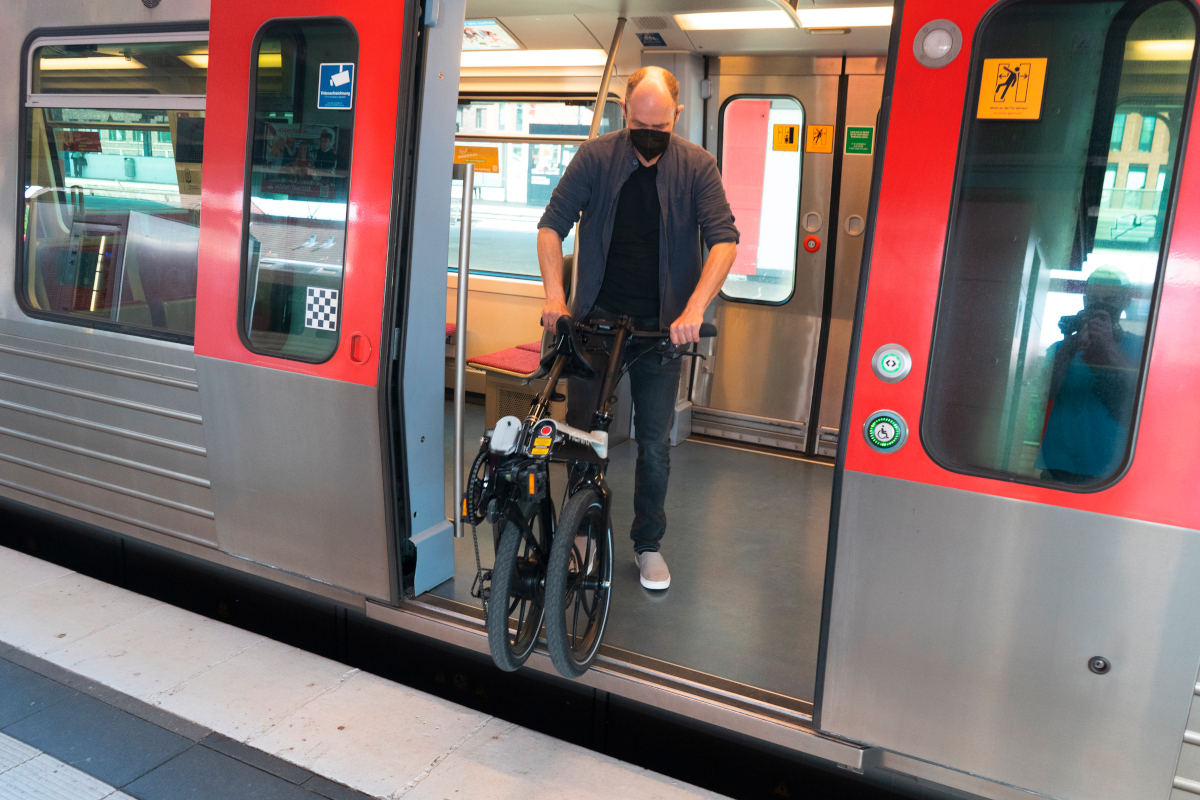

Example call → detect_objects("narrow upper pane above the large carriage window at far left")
30 40 209 95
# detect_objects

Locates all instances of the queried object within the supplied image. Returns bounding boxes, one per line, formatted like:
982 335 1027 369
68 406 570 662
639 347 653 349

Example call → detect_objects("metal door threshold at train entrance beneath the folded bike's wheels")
366 597 869 770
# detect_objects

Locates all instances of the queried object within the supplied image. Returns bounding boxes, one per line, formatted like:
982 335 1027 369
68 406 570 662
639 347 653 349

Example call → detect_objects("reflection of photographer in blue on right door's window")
1038 267 1145 483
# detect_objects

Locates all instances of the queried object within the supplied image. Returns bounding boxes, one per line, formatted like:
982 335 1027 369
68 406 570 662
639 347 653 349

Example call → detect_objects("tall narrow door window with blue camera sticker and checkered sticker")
242 20 359 362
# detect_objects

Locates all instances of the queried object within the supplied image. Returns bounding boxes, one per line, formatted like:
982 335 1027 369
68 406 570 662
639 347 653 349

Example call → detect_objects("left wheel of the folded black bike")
487 513 548 672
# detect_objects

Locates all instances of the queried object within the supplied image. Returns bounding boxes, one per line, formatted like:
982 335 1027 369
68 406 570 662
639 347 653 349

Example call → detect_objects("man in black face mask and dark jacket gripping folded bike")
538 67 738 589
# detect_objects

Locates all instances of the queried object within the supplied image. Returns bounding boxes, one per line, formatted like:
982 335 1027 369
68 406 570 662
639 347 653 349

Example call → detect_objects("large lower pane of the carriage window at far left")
22 108 204 339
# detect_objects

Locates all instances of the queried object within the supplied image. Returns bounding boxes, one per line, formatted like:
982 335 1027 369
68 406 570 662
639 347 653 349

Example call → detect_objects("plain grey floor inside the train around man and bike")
433 403 833 702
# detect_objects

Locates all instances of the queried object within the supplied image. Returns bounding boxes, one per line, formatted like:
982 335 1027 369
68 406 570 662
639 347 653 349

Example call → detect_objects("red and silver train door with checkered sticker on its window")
189 0 408 600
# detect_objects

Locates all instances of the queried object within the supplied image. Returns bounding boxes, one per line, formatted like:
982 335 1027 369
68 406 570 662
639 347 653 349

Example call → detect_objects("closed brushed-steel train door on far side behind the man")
692 56 883 456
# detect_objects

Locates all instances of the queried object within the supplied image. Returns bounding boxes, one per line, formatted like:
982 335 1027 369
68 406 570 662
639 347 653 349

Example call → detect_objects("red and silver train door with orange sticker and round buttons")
815 0 1200 800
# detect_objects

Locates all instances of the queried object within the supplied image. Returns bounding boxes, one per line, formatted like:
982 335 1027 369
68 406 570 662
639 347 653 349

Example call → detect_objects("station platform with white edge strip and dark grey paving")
0 547 721 800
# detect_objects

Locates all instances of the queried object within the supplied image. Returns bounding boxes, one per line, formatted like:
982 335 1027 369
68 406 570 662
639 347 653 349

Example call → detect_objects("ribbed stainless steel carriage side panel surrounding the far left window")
0 0 216 549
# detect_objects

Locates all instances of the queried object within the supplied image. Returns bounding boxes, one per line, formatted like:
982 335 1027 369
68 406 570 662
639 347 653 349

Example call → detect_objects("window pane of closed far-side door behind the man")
721 97 804 303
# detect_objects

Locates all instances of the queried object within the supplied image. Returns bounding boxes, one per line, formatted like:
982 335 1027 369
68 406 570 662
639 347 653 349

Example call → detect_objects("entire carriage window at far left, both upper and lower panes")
18 42 206 341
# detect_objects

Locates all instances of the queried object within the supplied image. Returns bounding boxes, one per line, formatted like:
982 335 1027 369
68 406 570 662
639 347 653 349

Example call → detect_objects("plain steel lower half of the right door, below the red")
820 470 1200 800
